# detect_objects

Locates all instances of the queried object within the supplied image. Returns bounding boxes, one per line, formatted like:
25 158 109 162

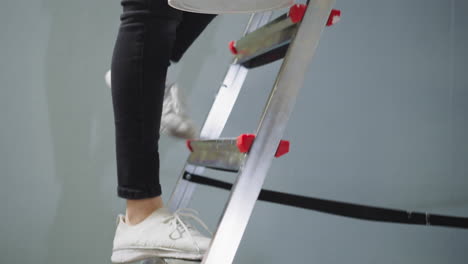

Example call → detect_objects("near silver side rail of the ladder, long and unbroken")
202 0 335 264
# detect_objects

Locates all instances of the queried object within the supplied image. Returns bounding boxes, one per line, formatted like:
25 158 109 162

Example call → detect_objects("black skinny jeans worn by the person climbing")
111 0 215 199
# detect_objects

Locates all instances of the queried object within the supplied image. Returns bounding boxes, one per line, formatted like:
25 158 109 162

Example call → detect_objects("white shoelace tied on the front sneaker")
164 208 213 252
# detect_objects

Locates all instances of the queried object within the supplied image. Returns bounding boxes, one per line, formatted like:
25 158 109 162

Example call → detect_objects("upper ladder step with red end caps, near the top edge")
229 4 341 68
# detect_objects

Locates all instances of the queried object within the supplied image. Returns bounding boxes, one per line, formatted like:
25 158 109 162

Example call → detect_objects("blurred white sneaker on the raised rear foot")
105 71 197 139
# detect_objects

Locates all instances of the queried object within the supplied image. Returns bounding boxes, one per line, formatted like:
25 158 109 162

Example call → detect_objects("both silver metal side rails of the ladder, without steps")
169 0 336 264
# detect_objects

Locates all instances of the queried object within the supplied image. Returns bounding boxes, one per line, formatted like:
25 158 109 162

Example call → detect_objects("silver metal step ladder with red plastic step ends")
157 0 340 264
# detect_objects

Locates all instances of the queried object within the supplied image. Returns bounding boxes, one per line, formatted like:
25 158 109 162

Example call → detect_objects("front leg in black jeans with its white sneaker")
111 0 215 263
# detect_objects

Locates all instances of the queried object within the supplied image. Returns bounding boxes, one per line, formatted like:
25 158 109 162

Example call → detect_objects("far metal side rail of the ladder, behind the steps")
168 11 273 211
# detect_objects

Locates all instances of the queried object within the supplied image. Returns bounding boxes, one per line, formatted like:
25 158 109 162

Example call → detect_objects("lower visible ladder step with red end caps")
187 134 290 172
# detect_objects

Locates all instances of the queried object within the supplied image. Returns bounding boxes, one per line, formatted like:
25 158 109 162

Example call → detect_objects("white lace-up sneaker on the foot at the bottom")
111 208 211 263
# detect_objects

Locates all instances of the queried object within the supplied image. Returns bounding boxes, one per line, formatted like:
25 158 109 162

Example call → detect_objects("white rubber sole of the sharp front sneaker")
111 249 203 264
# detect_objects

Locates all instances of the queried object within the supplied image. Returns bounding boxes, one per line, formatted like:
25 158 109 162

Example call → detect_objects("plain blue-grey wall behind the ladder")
0 0 468 264
